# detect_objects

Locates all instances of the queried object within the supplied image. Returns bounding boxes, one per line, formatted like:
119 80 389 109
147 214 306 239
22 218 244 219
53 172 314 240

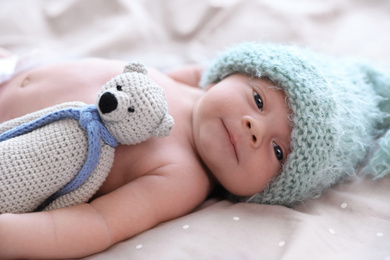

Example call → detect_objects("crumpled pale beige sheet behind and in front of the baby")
0 0 390 260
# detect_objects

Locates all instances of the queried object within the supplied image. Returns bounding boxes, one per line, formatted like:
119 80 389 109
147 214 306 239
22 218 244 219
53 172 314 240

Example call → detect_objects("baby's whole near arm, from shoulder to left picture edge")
0 166 207 259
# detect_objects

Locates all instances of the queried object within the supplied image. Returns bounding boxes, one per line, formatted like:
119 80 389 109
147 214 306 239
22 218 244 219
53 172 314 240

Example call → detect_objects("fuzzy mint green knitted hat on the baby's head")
201 43 390 206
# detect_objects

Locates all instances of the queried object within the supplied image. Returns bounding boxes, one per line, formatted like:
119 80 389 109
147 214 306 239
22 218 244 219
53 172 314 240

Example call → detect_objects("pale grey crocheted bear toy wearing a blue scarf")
0 63 173 214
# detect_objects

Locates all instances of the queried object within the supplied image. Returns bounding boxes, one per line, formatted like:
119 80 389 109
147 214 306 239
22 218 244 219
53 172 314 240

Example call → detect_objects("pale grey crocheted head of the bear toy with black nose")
96 62 174 145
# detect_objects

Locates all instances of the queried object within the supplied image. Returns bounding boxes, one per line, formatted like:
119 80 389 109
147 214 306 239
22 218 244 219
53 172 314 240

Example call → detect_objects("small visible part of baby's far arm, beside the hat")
167 64 203 87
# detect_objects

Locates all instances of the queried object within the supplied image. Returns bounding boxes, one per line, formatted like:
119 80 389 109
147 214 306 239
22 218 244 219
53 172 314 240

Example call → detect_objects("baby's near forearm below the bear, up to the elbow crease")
0 204 109 259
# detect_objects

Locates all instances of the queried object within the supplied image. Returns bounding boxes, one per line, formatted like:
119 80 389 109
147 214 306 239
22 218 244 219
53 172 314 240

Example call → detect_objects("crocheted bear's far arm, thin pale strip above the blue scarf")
0 102 85 134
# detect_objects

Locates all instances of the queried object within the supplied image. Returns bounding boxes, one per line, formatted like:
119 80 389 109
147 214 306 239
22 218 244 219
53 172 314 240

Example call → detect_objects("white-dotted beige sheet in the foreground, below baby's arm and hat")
86 178 390 260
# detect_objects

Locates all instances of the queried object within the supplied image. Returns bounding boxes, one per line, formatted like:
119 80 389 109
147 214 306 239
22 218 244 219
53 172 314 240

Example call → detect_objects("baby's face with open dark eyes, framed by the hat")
194 74 292 196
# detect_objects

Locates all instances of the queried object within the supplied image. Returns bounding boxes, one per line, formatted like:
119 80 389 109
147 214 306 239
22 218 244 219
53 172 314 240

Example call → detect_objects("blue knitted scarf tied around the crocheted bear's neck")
0 105 118 211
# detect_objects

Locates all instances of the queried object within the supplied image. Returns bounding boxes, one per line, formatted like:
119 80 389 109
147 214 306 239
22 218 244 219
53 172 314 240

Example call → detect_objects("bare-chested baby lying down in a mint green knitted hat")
0 43 390 258
